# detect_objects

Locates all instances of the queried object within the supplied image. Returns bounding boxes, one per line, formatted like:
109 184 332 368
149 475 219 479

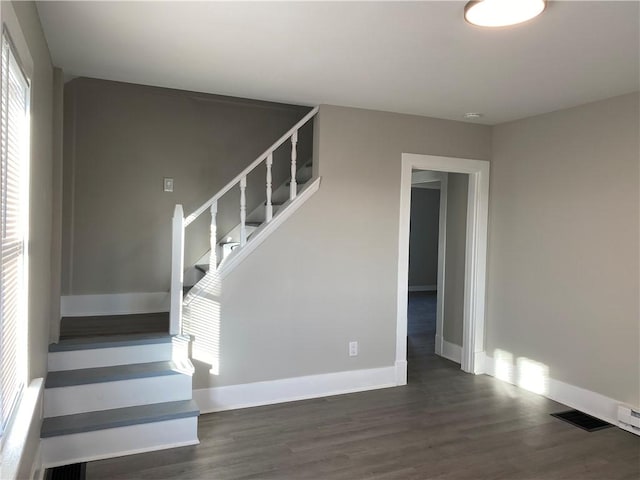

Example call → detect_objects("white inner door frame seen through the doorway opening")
409 169 449 355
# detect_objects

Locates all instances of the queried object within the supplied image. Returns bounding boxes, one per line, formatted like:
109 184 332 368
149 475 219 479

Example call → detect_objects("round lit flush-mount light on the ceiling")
464 0 547 27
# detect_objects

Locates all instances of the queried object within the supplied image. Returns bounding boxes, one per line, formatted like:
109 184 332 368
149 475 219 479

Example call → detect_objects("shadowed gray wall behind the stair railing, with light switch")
62 78 311 295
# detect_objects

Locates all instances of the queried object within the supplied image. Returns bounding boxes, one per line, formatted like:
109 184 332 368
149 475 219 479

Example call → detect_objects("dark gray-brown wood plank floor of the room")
87 295 640 480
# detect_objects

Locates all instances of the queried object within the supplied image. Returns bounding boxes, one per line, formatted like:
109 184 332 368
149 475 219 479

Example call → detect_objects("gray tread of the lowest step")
40 400 200 438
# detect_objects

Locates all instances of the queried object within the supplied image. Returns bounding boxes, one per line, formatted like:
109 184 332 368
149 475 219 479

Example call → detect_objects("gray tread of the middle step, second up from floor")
45 361 184 388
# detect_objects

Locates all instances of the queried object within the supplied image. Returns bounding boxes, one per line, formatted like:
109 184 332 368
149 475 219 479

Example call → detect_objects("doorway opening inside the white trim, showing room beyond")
407 169 468 376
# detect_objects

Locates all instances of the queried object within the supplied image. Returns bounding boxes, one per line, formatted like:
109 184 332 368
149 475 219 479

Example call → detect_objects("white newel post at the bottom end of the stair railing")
169 205 184 335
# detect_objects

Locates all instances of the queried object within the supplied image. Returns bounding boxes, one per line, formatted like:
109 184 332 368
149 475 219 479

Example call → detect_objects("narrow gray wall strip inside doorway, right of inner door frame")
442 173 469 346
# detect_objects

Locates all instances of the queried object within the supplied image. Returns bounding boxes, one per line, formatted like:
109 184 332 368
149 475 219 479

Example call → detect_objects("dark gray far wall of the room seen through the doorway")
409 187 440 287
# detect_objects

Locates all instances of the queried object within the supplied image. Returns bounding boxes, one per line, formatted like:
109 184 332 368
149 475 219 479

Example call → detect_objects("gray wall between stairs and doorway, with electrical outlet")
194 105 491 388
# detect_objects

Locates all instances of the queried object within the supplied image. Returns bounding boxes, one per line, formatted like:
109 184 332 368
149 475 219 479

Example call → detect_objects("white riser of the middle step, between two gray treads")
44 375 191 417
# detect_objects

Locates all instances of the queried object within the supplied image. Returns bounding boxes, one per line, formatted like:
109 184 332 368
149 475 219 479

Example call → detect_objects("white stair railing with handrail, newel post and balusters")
169 107 318 335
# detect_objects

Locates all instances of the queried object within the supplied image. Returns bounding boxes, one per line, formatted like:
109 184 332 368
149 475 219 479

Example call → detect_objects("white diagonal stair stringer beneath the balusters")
183 177 321 307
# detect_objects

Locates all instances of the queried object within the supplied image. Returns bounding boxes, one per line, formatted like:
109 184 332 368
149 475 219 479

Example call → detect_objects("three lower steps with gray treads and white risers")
40 314 199 468
